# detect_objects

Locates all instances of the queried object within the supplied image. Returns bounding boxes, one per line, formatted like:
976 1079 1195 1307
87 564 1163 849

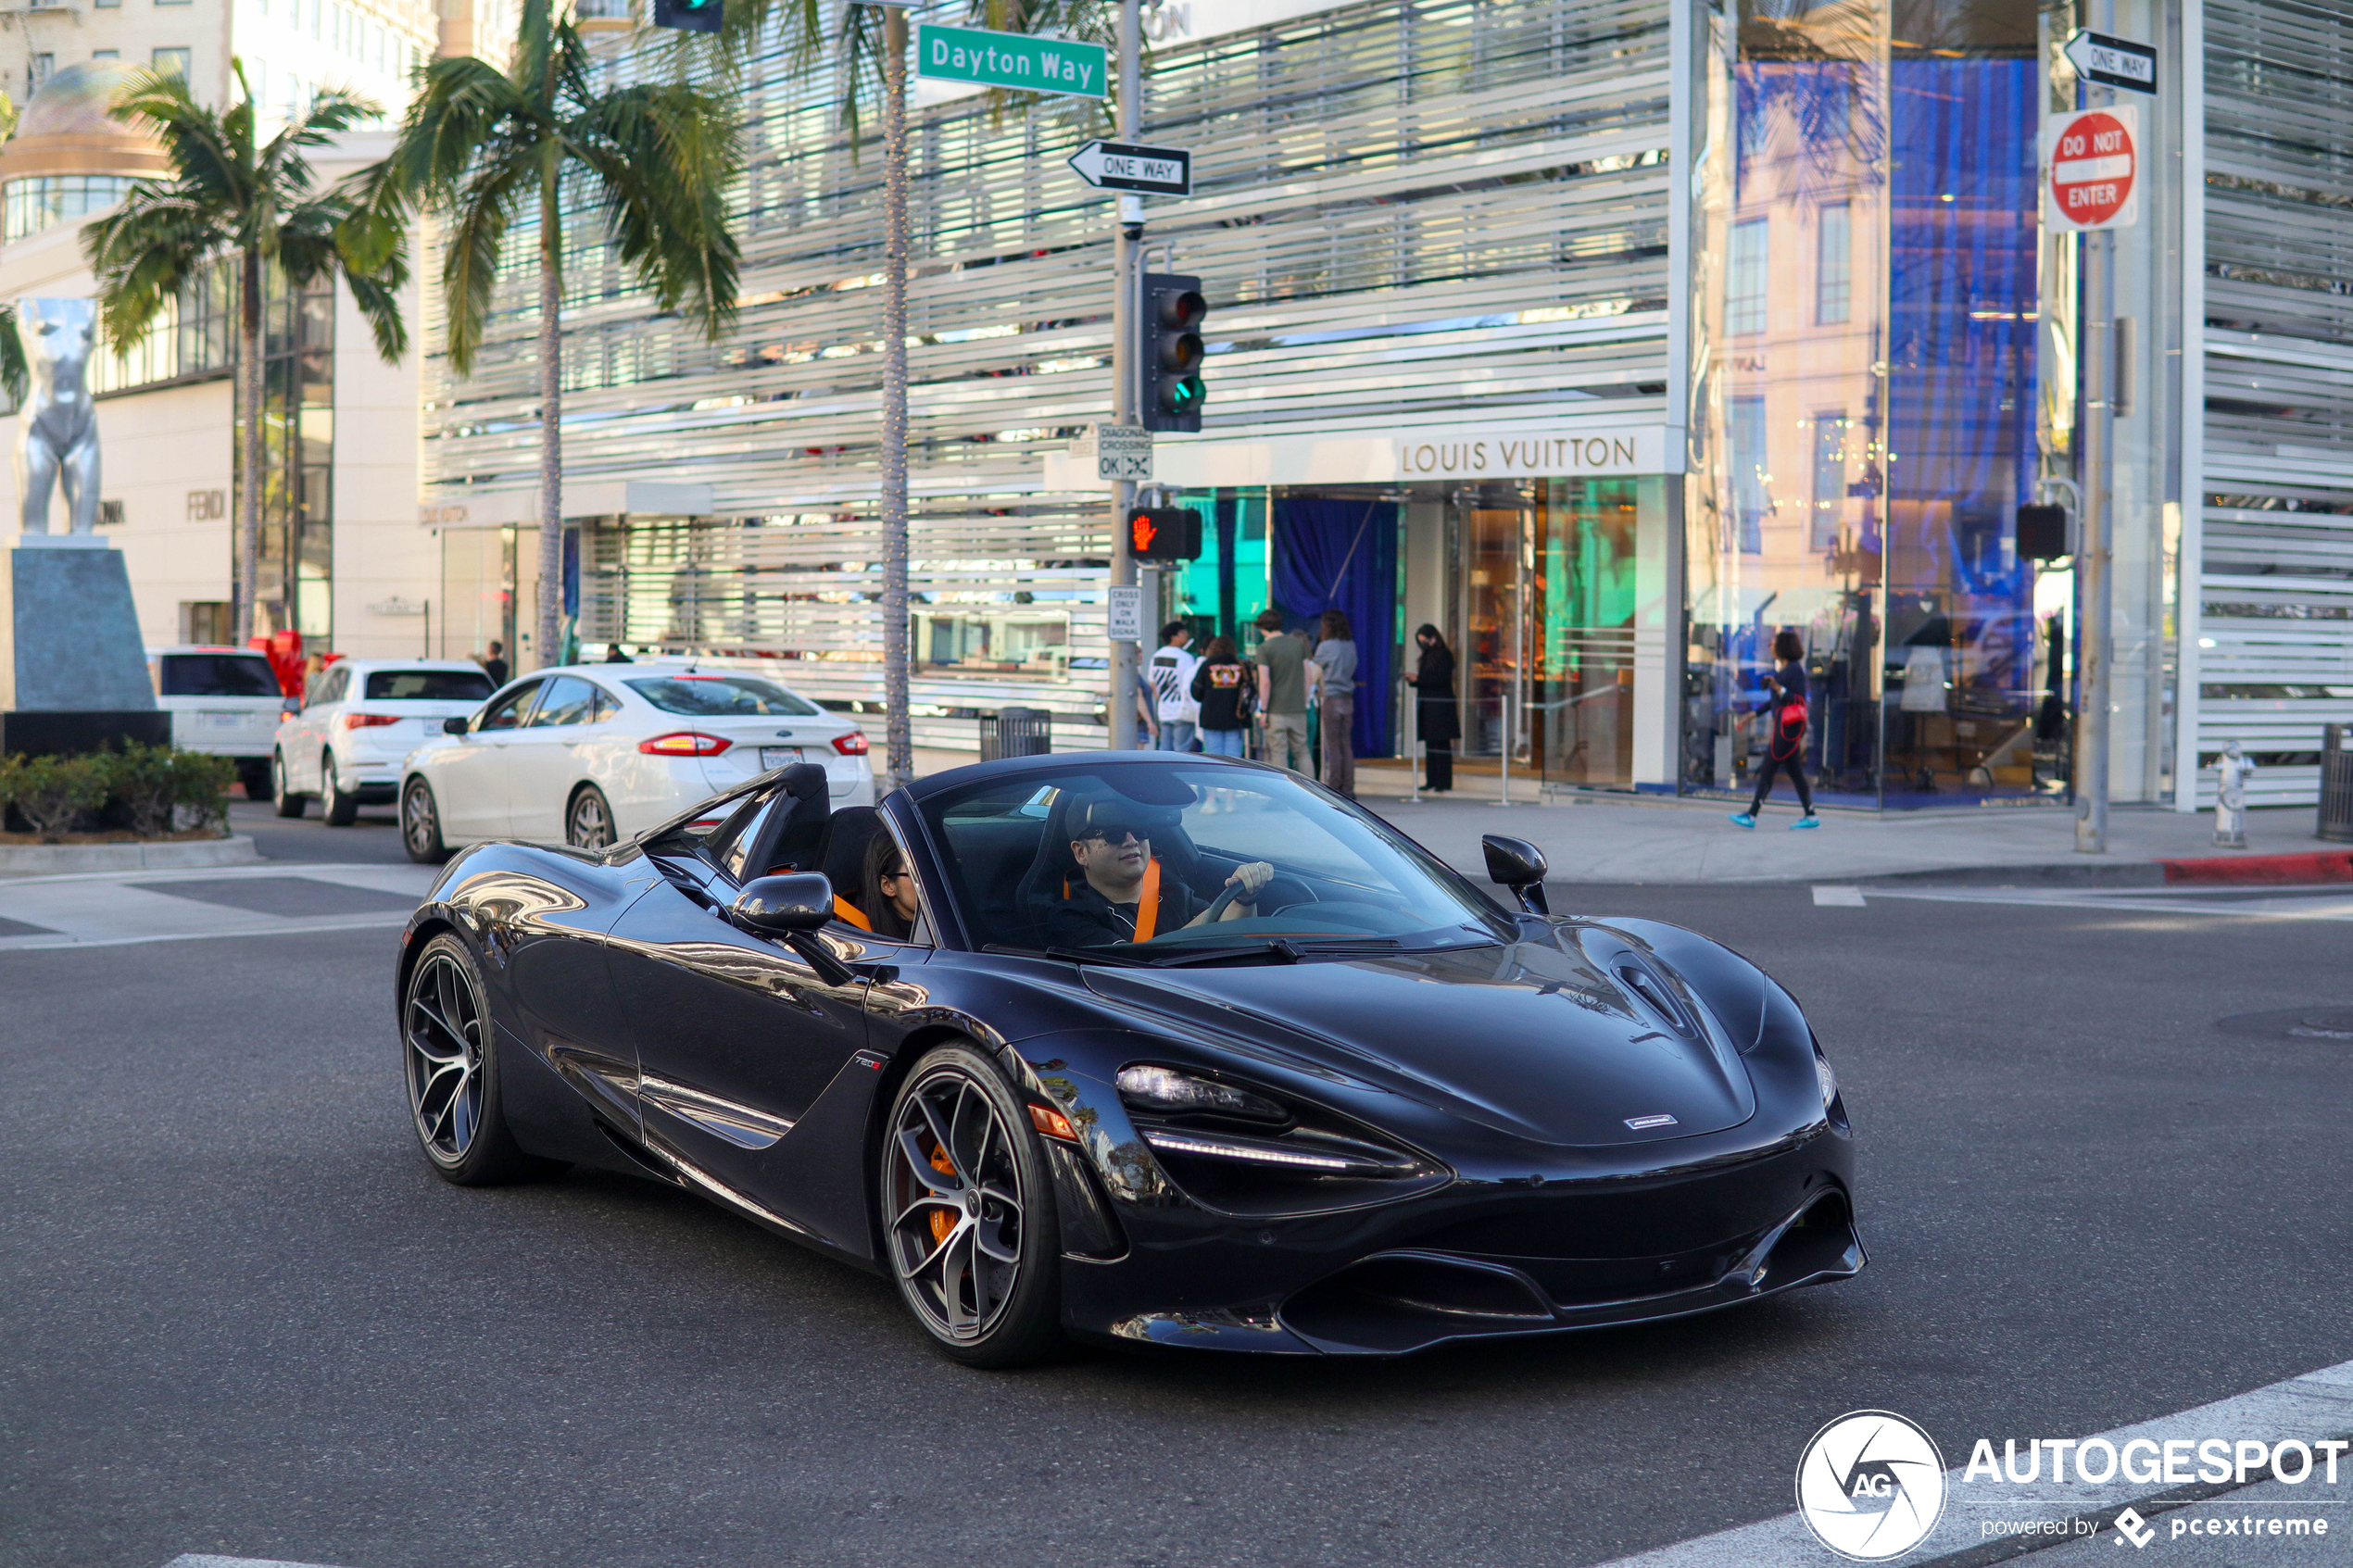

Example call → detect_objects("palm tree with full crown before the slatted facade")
350 0 744 665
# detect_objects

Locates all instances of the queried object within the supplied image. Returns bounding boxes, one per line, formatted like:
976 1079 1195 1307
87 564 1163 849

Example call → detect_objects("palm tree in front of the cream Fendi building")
82 61 407 642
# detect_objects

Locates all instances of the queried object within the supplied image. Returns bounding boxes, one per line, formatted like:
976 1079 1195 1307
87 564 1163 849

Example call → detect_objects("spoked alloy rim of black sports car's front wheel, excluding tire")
885 1065 1028 1340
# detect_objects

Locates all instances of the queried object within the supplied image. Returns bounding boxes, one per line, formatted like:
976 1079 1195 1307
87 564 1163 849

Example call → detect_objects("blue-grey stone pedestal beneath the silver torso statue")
0 533 171 752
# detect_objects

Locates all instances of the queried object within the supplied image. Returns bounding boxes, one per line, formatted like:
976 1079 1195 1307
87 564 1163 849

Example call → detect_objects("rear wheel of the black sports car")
400 931 562 1187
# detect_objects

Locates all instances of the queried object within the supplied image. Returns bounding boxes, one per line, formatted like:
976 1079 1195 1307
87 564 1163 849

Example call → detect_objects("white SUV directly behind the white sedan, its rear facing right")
271 659 492 827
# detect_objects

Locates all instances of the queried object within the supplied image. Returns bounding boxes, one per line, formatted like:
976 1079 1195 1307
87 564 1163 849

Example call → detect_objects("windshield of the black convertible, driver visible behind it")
923 761 1508 961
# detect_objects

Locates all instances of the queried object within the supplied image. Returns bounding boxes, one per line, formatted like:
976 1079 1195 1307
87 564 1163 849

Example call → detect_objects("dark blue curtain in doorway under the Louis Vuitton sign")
1273 496 1398 757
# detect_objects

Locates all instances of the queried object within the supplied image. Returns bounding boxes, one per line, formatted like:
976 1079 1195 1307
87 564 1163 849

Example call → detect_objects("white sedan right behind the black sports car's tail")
400 663 875 863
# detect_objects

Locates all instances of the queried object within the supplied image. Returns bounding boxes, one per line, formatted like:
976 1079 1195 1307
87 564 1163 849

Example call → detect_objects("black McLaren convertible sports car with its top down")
396 752 1864 1366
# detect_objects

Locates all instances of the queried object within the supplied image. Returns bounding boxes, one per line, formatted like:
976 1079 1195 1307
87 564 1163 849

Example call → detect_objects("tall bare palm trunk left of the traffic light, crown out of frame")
883 5 915 790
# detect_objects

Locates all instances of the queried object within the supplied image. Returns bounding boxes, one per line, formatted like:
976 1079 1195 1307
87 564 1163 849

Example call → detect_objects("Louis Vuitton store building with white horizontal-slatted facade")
409 0 2353 809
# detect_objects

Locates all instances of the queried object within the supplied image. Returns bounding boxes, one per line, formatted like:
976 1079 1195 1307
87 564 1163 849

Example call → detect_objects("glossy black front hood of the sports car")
1085 926 1755 1148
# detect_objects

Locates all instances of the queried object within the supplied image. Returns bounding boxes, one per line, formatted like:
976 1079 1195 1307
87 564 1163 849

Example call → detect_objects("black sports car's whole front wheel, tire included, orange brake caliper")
875 1041 1062 1366
